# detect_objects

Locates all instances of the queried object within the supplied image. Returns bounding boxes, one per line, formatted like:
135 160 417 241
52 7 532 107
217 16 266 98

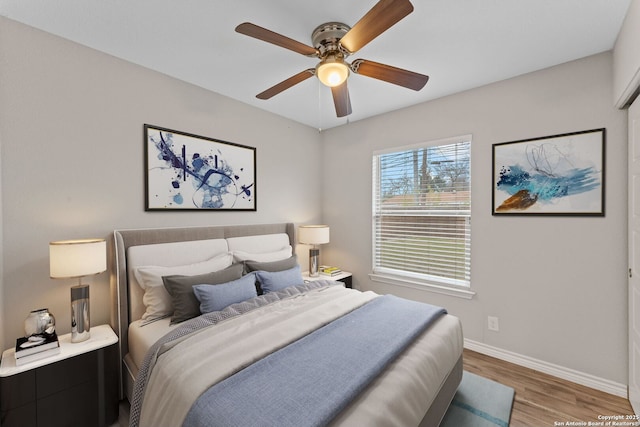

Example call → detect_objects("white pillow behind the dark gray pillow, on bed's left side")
134 252 233 319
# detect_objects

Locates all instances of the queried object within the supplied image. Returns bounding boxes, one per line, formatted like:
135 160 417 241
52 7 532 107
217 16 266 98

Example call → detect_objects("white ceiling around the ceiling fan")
0 0 631 129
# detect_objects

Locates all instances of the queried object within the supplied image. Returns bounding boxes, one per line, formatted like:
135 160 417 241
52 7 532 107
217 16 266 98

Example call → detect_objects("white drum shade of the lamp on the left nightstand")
49 239 107 279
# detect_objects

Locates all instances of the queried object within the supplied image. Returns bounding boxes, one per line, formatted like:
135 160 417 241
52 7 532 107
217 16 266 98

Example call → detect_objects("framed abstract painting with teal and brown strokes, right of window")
492 129 605 216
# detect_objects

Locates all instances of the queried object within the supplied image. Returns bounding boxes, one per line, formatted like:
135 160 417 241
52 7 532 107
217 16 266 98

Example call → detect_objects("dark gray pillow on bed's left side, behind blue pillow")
162 263 243 325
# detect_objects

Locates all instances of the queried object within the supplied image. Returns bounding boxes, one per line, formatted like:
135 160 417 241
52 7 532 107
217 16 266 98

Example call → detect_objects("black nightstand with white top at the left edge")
0 325 118 427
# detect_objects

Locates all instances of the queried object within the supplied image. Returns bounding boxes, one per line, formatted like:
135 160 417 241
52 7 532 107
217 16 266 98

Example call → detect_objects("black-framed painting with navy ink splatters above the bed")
145 125 256 210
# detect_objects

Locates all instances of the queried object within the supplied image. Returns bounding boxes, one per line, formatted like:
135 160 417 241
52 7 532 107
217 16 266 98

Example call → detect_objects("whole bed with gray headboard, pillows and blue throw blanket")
112 223 462 427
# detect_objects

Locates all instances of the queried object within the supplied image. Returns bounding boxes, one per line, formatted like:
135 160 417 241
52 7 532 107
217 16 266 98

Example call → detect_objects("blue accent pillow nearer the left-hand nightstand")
193 273 258 314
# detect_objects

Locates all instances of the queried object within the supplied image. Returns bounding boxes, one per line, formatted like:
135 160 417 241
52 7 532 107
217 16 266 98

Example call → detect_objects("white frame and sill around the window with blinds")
369 134 475 299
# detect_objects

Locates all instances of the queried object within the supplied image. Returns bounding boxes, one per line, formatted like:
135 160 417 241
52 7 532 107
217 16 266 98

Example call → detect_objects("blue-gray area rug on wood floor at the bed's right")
440 371 515 427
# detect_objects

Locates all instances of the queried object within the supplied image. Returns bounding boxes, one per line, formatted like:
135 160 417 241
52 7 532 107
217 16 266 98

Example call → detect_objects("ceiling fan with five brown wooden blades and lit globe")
236 0 429 117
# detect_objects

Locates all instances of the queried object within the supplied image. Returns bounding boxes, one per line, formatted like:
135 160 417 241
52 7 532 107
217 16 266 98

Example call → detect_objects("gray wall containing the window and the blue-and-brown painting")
323 53 627 384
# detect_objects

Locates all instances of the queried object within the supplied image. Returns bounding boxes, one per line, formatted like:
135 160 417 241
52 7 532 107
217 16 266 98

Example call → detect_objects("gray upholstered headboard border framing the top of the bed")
110 223 296 398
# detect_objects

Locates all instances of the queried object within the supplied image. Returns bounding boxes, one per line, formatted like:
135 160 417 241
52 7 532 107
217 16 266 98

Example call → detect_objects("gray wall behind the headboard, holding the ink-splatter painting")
0 17 321 348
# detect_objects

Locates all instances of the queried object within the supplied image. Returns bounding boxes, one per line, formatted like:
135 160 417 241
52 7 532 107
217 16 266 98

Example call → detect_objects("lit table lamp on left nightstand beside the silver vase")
49 239 107 342
